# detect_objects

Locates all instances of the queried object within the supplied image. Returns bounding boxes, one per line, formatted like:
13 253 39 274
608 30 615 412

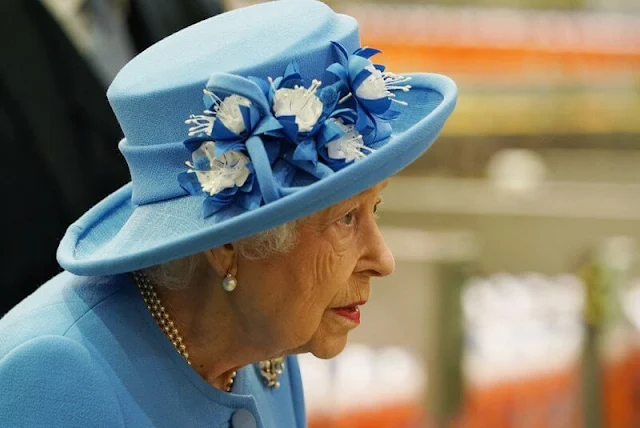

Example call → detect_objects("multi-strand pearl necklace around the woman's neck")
133 272 237 392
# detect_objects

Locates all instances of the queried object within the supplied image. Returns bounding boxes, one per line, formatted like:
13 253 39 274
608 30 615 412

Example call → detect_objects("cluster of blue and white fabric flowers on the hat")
178 42 411 217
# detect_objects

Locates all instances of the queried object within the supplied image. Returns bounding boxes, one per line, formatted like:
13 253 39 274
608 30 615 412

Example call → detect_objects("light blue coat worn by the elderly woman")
0 272 306 428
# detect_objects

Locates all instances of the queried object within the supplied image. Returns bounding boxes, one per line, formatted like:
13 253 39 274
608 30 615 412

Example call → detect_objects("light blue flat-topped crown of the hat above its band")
107 0 360 146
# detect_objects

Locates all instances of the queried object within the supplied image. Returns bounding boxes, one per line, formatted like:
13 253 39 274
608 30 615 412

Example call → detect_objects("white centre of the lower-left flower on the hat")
187 142 250 196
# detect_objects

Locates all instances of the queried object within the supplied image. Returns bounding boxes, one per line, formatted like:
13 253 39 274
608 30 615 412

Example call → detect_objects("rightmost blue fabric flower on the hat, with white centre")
327 42 411 142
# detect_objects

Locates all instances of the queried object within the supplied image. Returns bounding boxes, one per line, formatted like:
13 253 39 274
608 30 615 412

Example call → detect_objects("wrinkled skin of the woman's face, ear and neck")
162 181 395 388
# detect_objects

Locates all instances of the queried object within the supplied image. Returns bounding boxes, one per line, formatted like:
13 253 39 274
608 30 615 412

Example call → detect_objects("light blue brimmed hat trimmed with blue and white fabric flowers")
57 0 457 275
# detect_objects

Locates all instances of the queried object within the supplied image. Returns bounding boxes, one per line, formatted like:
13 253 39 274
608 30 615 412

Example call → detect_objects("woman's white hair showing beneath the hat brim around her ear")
144 222 297 290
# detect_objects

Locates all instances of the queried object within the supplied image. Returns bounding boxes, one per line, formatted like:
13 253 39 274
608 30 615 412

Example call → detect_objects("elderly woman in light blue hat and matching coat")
0 0 456 428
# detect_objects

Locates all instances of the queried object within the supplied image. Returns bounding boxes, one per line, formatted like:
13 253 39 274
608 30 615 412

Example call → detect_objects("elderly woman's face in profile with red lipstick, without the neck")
234 181 395 358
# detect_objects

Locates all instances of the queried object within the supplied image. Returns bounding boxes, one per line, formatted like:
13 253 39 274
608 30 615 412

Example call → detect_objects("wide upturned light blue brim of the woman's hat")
57 73 457 275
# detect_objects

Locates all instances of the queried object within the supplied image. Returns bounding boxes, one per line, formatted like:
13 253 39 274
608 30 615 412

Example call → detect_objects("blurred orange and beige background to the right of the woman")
288 0 640 428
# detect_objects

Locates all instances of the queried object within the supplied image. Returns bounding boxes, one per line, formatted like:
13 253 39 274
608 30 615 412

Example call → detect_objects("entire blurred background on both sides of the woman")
0 0 640 428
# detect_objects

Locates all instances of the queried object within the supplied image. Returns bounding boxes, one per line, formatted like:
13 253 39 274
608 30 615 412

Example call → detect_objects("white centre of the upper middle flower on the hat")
273 80 323 132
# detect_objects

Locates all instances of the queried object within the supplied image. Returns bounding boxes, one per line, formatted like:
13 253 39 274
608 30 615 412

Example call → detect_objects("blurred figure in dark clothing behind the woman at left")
0 0 222 317
